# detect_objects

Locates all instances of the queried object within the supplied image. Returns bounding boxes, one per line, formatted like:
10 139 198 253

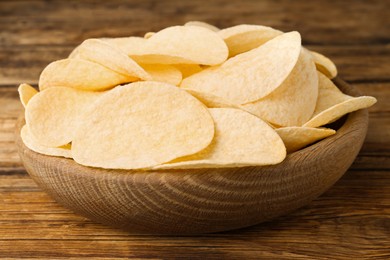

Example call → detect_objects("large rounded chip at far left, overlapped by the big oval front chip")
25 87 102 147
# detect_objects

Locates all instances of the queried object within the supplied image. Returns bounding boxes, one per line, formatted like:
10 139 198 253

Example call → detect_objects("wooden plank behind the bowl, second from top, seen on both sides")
0 45 390 85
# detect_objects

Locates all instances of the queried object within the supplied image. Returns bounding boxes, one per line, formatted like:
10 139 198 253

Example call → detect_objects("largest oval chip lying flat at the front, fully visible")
72 81 214 169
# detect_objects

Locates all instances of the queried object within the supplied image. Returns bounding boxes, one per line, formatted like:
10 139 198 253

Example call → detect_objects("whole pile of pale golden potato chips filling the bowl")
19 22 376 169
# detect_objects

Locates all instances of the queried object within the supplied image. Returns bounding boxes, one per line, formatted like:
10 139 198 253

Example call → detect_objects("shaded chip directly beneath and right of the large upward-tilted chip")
242 49 318 126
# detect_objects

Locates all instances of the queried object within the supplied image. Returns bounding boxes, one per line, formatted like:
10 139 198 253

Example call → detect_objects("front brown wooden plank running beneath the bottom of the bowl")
0 171 390 259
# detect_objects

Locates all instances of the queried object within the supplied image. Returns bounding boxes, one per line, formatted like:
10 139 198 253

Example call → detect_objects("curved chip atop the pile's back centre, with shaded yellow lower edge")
130 26 228 65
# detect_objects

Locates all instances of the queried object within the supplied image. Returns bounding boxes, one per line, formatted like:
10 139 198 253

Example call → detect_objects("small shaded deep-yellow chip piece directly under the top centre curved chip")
141 64 182 86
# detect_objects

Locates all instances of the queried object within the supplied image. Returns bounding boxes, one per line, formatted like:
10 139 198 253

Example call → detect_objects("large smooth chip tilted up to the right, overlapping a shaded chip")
181 32 301 104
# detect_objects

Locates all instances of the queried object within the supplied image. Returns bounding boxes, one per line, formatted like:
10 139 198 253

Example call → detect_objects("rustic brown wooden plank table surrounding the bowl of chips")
0 0 390 259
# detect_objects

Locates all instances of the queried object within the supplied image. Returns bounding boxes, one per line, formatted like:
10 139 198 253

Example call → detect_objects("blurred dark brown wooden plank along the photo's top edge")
0 0 390 45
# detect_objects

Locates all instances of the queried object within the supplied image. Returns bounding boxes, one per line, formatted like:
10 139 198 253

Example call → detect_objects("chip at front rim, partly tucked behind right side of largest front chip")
155 108 286 169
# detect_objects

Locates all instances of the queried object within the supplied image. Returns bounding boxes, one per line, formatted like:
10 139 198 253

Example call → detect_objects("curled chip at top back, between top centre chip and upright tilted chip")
218 24 283 57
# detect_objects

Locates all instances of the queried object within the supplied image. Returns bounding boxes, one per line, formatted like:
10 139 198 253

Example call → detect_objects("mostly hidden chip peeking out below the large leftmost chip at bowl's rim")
20 125 72 158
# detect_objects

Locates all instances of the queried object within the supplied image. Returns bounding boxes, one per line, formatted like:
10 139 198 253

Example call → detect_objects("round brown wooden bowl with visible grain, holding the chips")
16 79 368 234
